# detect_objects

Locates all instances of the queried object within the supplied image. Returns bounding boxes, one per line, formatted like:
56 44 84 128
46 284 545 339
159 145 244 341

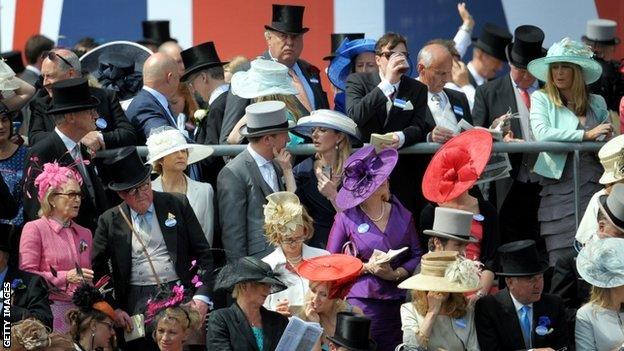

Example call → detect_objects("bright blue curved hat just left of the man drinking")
327 39 376 90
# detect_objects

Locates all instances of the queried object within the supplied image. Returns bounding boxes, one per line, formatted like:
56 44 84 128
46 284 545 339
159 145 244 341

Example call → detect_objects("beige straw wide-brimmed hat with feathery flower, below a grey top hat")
399 251 480 293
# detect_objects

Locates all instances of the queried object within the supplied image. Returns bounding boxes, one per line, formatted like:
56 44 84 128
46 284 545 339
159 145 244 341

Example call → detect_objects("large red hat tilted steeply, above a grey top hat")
422 129 492 203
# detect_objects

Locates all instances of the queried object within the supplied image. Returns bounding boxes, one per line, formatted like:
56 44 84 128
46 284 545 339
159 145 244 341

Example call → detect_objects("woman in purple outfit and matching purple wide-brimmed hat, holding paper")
327 146 421 350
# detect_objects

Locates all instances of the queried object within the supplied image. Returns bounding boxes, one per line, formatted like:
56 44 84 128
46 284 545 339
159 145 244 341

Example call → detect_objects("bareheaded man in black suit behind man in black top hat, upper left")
28 49 136 148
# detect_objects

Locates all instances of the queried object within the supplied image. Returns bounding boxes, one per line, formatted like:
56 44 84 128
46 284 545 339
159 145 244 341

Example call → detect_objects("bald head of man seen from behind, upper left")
143 52 180 98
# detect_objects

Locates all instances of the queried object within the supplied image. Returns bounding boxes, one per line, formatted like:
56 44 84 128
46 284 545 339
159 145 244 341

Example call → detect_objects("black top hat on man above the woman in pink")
48 77 100 114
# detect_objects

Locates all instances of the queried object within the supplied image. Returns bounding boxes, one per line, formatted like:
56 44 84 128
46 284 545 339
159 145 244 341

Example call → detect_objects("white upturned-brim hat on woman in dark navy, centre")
293 109 360 143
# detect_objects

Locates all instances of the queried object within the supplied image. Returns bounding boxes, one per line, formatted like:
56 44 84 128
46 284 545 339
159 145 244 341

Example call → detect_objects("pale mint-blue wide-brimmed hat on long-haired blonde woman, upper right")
527 38 602 84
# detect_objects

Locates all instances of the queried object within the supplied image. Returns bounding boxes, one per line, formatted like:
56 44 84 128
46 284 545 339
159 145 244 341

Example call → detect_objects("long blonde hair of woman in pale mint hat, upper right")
544 62 589 116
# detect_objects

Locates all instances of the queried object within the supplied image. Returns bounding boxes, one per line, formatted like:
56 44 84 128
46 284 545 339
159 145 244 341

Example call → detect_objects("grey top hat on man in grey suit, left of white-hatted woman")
240 101 296 137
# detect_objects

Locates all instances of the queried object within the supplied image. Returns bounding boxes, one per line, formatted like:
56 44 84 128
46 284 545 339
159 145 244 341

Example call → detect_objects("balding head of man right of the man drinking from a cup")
418 44 453 93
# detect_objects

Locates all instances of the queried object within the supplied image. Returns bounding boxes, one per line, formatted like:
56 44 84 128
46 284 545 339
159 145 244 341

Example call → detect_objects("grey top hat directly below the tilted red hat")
423 207 479 243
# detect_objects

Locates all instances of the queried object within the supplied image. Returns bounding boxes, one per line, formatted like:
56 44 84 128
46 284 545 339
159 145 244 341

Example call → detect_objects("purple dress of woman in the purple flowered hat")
327 196 422 351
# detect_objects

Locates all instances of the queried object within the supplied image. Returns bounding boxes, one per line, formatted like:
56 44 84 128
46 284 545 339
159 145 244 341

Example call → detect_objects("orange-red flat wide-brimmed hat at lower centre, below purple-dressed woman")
297 254 363 299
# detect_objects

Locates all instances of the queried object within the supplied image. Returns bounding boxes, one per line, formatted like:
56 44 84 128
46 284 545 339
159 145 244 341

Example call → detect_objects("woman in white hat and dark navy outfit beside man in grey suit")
293 109 360 247
